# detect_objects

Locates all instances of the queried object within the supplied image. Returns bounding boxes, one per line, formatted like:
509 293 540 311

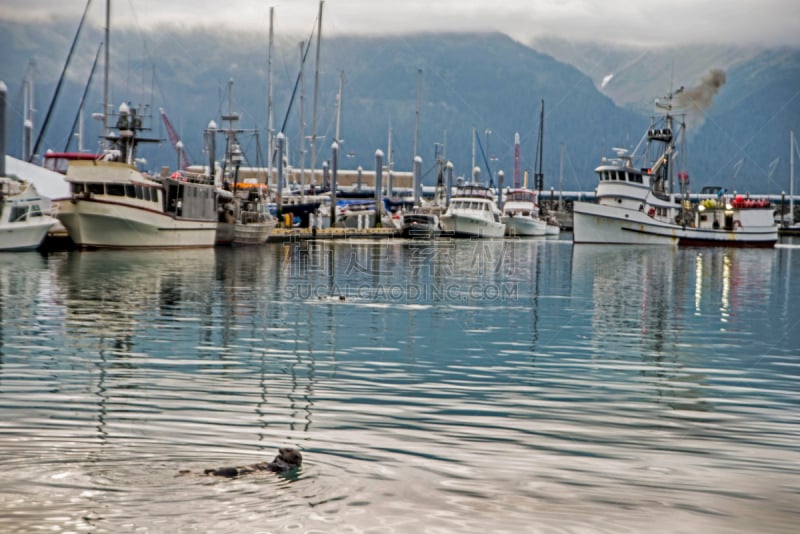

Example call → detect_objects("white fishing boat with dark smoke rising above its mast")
573 87 778 247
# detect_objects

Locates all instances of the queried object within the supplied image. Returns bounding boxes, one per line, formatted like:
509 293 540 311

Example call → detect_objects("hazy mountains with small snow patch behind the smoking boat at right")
530 39 800 194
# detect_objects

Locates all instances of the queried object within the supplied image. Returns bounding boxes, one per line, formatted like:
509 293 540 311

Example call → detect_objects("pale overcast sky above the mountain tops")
0 0 800 46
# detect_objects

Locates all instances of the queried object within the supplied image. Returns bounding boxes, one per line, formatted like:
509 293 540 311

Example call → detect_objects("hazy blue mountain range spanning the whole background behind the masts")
0 17 800 197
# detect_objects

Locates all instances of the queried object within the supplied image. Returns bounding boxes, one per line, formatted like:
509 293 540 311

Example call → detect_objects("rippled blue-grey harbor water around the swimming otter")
0 240 800 534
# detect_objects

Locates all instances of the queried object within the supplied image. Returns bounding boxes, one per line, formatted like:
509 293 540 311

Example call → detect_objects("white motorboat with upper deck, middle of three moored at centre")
439 184 506 237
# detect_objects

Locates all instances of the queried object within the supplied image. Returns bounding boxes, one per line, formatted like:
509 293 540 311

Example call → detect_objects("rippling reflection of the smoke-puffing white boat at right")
572 245 785 412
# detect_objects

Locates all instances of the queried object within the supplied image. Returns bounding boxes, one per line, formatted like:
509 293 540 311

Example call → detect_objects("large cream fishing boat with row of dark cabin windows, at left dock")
57 104 217 248
